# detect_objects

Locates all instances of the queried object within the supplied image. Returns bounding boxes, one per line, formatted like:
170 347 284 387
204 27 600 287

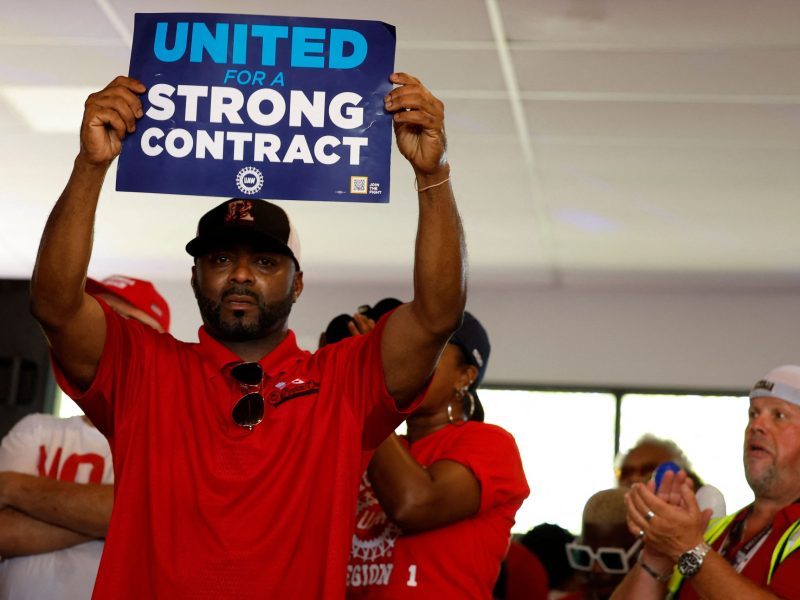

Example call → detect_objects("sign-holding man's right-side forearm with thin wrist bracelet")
413 163 466 339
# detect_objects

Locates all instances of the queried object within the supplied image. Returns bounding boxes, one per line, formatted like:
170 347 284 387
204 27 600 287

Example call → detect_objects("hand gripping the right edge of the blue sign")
384 73 447 175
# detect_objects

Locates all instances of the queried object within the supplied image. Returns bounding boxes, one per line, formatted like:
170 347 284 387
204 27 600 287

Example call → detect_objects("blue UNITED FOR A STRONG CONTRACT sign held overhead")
117 13 395 202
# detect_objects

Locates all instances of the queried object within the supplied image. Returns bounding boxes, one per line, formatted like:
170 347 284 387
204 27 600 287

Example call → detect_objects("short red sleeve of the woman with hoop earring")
438 423 530 512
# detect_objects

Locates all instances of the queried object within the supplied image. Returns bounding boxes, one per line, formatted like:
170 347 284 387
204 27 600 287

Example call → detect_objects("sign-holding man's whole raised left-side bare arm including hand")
31 77 145 388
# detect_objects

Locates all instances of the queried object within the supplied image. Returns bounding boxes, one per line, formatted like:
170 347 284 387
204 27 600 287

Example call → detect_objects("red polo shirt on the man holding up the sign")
56 305 420 600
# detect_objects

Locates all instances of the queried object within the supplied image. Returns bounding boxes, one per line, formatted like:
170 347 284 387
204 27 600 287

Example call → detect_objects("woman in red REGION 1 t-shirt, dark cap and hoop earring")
340 312 529 600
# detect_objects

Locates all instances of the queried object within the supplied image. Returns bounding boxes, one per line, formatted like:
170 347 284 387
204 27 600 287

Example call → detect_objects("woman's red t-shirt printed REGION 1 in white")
347 422 530 600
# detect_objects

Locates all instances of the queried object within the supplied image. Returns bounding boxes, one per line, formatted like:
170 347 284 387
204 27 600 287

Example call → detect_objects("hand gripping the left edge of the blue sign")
81 76 145 166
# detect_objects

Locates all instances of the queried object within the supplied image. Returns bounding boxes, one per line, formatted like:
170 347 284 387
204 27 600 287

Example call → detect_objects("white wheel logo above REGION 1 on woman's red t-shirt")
352 473 401 561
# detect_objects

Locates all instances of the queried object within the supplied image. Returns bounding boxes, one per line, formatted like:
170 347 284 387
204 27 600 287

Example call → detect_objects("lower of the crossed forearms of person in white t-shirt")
0 508 91 558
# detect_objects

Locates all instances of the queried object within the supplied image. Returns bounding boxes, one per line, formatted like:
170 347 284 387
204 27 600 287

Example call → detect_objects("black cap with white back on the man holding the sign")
186 198 300 270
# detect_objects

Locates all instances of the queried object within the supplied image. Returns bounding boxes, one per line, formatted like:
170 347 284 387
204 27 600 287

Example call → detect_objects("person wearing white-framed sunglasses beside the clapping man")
563 488 641 600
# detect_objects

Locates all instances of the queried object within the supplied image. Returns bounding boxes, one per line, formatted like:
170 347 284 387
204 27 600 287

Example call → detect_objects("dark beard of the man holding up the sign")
195 288 293 342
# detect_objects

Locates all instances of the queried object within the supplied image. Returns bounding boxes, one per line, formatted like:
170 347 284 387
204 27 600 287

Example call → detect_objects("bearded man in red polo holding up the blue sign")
32 73 465 599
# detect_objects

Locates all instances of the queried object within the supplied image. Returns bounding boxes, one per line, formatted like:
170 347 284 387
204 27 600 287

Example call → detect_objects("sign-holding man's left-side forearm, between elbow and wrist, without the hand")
31 155 108 329
